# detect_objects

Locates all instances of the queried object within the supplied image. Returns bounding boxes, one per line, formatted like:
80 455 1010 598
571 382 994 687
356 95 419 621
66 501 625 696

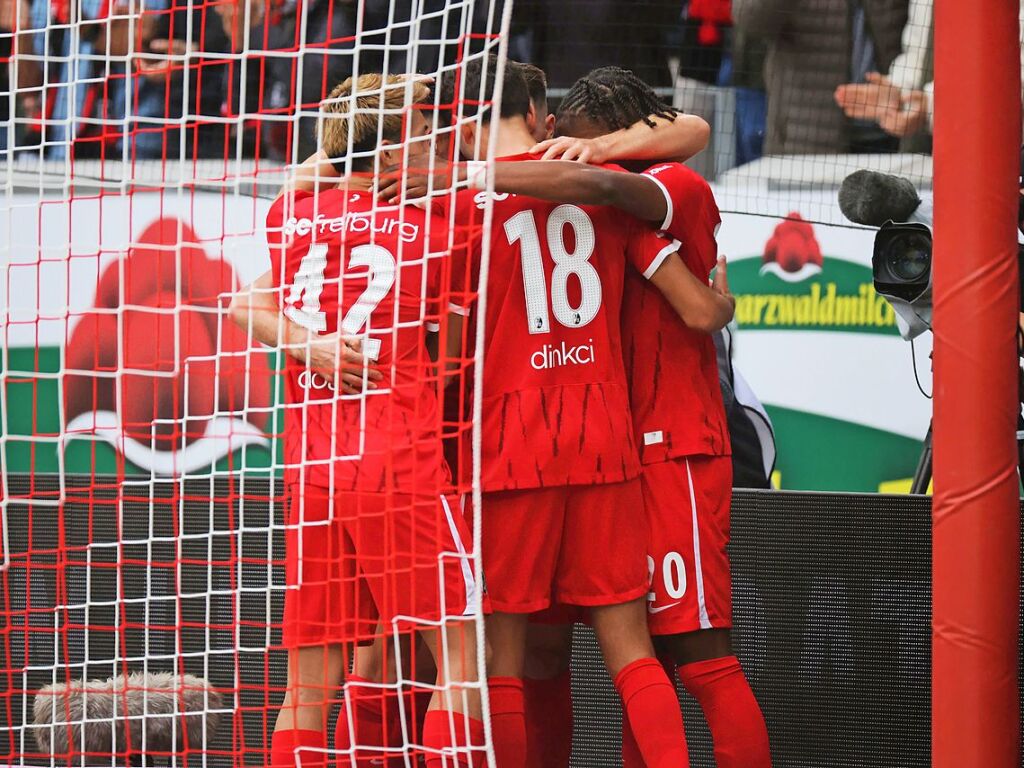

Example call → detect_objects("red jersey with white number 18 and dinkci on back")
453 155 677 490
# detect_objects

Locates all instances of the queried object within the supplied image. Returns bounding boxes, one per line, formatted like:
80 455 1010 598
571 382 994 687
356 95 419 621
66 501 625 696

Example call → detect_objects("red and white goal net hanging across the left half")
0 0 511 766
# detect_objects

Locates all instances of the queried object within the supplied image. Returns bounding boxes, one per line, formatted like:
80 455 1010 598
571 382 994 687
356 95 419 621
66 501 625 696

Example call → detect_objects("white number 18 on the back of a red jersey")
505 205 601 334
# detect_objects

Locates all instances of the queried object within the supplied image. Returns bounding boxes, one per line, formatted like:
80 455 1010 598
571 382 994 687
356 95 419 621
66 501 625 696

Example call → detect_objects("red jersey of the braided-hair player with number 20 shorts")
623 163 730 464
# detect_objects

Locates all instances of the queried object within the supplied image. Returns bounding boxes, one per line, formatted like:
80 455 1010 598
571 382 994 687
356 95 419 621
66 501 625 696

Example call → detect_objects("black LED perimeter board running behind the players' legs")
0 475 1019 768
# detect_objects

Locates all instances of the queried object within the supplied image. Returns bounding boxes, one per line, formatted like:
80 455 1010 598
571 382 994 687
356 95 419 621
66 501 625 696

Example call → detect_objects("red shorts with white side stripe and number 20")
641 456 732 635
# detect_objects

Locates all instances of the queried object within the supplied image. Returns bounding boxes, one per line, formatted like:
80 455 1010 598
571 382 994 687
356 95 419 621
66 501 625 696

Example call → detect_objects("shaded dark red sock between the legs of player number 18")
522 670 572 768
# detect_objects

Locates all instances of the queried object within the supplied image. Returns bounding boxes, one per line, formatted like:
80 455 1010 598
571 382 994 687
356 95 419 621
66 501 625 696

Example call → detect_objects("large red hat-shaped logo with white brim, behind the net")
65 217 270 474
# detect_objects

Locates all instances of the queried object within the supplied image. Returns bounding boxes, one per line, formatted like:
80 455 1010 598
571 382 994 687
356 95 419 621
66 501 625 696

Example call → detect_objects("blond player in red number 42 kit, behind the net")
232 75 483 766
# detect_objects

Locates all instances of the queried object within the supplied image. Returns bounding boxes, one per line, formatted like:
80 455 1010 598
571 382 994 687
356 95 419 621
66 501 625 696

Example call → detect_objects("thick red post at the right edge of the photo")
932 0 1021 768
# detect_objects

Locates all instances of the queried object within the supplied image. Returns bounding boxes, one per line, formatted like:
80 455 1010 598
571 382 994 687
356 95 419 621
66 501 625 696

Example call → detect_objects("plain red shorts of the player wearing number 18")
481 479 647 613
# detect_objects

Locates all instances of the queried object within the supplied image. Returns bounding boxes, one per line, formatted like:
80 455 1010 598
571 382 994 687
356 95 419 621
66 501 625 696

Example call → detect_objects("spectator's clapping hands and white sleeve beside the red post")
836 0 1024 148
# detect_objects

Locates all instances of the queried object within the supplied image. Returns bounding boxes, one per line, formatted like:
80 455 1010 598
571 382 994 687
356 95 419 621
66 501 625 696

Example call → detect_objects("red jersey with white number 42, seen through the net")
267 189 460 494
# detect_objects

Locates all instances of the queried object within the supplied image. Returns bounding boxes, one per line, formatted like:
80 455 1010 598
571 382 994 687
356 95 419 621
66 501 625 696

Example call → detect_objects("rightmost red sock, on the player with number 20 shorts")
679 656 771 768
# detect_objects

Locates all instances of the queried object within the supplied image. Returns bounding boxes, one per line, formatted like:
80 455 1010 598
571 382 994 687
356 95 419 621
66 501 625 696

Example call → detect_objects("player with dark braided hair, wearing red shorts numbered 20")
460 67 771 768
